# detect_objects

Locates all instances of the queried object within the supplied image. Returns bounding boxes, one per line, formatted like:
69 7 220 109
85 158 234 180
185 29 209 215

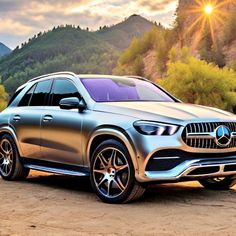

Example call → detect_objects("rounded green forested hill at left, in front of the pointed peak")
0 26 118 93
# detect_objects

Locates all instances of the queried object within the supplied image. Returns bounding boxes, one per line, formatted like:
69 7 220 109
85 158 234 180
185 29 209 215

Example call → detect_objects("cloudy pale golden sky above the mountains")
0 0 178 49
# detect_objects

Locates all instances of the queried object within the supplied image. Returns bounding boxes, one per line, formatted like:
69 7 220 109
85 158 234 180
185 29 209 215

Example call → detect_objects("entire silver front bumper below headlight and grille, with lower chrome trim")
127 128 236 182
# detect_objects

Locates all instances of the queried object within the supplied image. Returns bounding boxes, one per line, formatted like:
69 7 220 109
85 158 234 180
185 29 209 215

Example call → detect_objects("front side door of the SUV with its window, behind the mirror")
41 78 83 165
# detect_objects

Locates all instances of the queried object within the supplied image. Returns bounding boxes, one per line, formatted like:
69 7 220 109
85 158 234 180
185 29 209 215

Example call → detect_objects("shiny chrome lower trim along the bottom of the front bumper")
145 156 236 181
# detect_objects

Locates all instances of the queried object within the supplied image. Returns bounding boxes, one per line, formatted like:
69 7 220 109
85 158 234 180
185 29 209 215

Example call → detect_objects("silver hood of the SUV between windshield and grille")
94 102 236 125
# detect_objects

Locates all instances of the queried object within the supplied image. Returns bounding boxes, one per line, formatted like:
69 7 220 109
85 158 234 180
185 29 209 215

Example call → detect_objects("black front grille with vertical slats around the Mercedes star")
182 122 236 149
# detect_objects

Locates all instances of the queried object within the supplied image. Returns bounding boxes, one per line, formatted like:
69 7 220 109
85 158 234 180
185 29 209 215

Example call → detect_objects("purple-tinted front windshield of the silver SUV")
81 77 174 102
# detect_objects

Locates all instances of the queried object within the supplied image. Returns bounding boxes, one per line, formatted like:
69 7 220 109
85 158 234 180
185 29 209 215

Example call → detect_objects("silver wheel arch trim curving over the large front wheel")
86 128 139 175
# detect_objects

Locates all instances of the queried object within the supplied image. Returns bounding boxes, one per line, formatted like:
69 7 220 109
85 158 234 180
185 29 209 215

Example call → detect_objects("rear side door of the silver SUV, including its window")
10 80 52 159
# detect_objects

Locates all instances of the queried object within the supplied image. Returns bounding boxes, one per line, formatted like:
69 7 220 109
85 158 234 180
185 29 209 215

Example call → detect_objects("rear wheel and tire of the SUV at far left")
0 134 29 180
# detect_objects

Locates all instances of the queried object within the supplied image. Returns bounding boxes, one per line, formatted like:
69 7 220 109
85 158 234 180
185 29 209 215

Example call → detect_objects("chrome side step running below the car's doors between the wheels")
24 164 89 176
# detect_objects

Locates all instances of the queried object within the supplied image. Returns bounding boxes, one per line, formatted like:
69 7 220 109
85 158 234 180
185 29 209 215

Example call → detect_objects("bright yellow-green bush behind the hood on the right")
161 49 236 111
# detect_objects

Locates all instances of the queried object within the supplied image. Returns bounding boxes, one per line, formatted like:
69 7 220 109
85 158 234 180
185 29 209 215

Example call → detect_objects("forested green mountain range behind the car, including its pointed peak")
0 15 153 94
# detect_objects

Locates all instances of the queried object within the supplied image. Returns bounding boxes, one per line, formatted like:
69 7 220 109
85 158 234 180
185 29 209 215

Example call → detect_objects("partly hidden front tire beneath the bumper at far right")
199 176 236 190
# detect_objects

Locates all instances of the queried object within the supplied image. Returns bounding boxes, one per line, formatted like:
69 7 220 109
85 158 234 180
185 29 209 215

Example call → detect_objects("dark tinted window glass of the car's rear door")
29 80 52 106
